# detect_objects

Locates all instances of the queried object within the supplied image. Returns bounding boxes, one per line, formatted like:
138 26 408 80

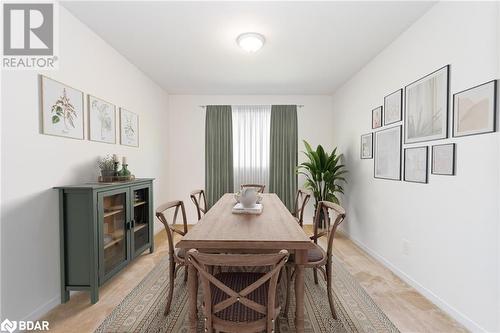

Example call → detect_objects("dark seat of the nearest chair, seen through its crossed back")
210 272 269 323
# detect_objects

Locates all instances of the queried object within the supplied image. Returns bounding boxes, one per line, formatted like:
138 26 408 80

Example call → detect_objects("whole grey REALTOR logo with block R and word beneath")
2 0 57 69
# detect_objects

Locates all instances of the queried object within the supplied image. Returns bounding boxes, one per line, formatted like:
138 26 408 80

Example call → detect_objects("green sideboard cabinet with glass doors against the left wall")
55 178 154 303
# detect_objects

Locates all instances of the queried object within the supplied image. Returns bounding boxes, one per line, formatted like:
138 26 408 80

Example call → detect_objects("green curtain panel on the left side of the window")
205 105 233 207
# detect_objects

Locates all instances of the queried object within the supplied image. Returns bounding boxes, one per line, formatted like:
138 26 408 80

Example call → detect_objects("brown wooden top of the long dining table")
176 193 314 250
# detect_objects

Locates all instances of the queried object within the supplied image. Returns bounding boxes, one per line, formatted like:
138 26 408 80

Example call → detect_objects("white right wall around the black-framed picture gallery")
332 2 500 331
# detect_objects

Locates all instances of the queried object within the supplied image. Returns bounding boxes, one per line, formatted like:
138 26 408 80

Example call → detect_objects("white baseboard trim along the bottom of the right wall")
337 230 488 333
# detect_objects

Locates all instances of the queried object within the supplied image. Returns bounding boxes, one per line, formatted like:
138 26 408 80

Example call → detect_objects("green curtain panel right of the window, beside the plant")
269 105 298 211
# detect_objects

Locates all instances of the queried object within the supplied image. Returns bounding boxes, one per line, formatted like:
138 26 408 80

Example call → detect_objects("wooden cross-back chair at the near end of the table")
188 249 288 333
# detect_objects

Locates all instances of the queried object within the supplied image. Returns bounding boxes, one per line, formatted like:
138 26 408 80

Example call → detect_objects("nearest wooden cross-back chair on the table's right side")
285 201 345 319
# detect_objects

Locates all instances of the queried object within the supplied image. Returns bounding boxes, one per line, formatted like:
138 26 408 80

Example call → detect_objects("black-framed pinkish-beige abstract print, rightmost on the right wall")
453 80 497 136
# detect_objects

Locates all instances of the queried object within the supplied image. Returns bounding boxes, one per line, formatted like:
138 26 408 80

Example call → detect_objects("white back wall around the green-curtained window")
168 95 333 223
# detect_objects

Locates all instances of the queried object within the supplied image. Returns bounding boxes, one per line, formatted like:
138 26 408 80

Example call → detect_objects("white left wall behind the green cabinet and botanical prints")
1 7 168 320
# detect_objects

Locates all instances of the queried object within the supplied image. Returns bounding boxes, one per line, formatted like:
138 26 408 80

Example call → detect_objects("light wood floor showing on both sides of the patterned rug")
38 226 464 333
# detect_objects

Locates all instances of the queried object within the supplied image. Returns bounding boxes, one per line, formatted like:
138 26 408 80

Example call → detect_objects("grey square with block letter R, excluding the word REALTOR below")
3 3 54 56
